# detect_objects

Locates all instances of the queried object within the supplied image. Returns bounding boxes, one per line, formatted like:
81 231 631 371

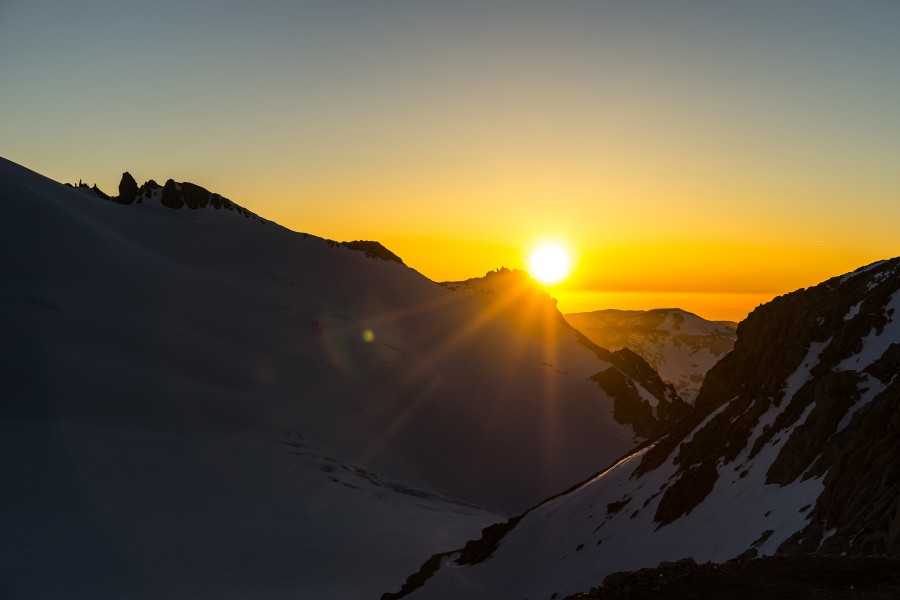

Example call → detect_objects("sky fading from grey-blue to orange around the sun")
0 0 900 320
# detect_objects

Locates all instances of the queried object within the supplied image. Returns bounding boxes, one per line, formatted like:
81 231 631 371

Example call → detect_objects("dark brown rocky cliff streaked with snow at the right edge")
639 259 900 536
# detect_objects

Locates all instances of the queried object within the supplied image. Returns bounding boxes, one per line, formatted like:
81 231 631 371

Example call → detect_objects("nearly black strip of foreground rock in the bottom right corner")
569 554 900 600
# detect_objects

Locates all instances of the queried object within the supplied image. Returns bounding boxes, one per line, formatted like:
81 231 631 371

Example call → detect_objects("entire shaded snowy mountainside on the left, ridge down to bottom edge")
0 151 692 598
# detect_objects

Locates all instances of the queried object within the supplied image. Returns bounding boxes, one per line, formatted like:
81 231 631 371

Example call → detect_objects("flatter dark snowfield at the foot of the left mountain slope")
0 420 499 600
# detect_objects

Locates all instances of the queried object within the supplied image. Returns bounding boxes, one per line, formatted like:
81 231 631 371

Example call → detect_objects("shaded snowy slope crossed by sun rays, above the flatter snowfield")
0 161 634 511
